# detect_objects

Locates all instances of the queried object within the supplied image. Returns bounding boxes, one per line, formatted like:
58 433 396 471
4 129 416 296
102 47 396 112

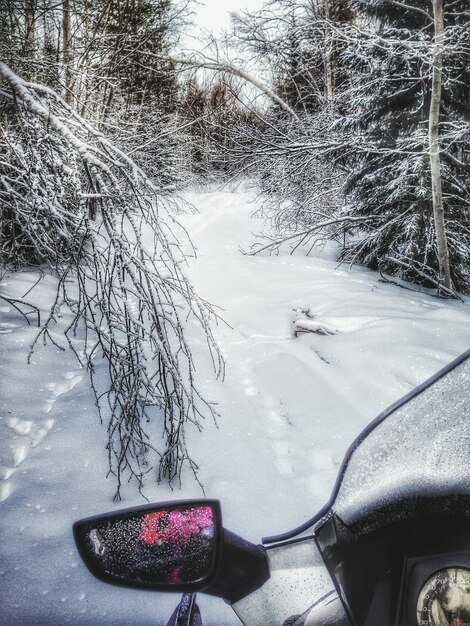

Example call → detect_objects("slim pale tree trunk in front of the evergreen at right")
429 0 452 289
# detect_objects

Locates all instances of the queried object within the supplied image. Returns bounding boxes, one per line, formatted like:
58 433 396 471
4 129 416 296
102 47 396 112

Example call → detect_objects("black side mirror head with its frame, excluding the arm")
73 500 222 591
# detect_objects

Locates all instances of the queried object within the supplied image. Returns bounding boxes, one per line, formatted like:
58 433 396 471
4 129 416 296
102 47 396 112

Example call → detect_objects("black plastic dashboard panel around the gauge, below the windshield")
317 502 470 626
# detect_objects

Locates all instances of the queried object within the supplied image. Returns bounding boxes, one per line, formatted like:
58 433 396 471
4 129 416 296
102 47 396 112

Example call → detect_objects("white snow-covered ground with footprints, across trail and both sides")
0 192 470 626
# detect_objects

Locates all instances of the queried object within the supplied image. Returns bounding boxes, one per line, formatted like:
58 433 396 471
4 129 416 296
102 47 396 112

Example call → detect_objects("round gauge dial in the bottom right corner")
417 567 470 626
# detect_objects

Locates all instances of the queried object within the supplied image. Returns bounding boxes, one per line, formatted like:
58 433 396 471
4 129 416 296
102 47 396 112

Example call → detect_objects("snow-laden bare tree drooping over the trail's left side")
0 63 223 499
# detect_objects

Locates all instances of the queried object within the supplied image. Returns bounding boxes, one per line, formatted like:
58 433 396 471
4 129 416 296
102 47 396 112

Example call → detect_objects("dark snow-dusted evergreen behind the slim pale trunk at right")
343 0 470 293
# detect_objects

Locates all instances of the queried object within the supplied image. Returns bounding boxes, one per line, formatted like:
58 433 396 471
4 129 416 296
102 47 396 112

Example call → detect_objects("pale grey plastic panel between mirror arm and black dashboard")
232 539 335 626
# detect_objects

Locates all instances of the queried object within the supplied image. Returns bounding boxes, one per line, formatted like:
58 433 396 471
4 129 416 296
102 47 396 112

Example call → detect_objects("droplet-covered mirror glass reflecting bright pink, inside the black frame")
85 506 216 585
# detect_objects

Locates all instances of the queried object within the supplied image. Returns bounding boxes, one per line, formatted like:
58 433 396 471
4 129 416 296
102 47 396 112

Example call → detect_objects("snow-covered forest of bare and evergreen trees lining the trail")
0 0 470 498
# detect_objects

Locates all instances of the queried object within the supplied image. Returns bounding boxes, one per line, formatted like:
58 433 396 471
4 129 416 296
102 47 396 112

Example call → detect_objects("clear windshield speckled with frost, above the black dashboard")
333 358 470 524
